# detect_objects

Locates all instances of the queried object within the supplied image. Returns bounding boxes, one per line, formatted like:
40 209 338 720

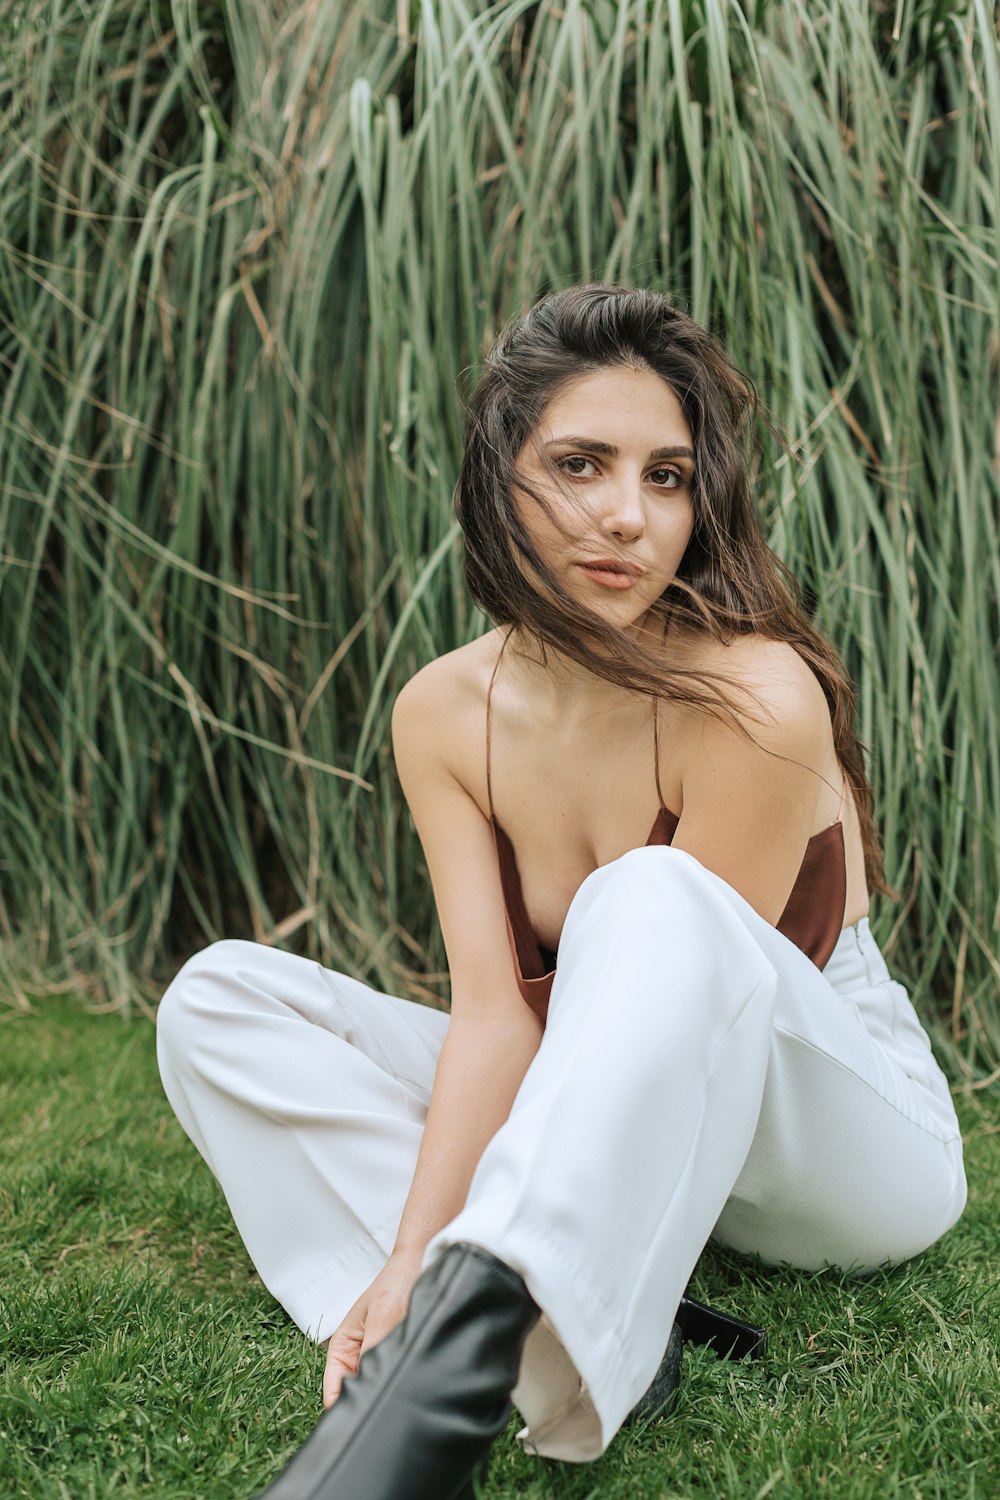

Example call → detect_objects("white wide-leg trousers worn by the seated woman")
157 846 966 1460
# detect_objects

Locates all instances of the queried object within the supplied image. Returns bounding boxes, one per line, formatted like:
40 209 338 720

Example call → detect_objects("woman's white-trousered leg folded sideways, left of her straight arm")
157 941 448 1341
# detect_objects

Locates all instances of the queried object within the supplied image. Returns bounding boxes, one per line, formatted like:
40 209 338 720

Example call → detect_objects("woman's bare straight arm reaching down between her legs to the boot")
324 659 541 1406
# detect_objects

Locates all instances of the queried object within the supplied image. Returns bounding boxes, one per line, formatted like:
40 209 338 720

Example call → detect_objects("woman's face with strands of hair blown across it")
514 366 694 629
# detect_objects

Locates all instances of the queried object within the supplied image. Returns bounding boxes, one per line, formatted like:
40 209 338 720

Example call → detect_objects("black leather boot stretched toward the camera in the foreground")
258 1245 540 1500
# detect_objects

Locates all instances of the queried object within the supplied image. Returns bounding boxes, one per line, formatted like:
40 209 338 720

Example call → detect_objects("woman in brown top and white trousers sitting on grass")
159 287 966 1500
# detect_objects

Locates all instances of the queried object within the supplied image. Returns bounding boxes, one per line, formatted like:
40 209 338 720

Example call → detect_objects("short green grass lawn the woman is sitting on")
0 1001 1000 1500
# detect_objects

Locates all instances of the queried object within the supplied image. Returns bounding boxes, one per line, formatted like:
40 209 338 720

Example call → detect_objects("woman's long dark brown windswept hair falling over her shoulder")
456 285 888 891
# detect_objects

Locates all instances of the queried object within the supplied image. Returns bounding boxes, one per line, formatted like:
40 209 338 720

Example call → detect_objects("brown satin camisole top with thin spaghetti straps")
486 632 847 1022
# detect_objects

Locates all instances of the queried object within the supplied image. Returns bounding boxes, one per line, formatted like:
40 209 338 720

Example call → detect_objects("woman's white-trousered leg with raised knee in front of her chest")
426 848 964 1460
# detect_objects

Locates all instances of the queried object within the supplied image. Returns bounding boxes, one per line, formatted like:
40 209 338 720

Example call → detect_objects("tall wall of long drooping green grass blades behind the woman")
0 0 1000 1082
